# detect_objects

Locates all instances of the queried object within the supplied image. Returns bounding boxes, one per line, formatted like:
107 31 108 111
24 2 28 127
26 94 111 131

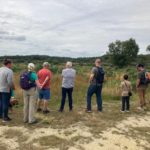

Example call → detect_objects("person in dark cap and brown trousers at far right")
136 64 148 110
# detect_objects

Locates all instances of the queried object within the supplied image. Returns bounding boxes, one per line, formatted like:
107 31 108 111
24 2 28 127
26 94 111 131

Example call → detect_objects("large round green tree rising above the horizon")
107 38 139 67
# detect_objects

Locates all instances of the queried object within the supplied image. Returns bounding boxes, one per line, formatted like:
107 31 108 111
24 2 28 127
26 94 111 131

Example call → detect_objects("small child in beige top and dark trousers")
120 75 132 112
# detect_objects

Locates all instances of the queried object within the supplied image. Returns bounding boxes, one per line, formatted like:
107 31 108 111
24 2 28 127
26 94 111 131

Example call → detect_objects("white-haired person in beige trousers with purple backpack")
20 63 41 124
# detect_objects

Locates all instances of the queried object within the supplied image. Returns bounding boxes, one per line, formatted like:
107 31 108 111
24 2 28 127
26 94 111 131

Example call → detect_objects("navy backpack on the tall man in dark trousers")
95 67 105 84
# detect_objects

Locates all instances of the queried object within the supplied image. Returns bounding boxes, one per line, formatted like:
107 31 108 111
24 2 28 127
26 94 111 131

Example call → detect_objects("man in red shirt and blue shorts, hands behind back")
37 62 52 114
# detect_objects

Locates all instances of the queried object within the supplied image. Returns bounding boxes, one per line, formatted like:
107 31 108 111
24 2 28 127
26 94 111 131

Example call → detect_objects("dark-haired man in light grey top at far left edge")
0 59 15 122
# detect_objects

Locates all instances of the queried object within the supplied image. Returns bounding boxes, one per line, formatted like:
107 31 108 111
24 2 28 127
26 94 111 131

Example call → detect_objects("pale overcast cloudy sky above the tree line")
0 0 150 57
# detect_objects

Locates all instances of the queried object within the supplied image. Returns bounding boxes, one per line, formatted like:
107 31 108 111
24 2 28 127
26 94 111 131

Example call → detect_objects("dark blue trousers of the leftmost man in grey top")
0 92 10 119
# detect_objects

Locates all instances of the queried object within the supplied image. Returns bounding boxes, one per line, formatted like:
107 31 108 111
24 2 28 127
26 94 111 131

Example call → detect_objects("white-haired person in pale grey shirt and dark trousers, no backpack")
59 62 76 112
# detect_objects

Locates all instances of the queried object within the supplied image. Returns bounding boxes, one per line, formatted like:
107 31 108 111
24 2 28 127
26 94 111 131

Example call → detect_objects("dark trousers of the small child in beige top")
122 96 130 111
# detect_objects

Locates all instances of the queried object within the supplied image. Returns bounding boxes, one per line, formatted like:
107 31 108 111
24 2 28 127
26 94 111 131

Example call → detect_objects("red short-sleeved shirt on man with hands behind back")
38 68 52 89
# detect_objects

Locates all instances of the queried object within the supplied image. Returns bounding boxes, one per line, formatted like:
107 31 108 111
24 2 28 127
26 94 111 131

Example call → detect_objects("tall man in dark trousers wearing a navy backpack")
87 59 105 113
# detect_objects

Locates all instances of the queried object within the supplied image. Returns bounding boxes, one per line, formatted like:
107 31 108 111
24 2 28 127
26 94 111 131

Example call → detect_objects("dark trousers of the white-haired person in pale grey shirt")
60 88 73 111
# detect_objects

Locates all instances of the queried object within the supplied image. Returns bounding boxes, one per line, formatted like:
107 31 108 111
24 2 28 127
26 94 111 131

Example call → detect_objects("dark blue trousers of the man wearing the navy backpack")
87 85 102 111
